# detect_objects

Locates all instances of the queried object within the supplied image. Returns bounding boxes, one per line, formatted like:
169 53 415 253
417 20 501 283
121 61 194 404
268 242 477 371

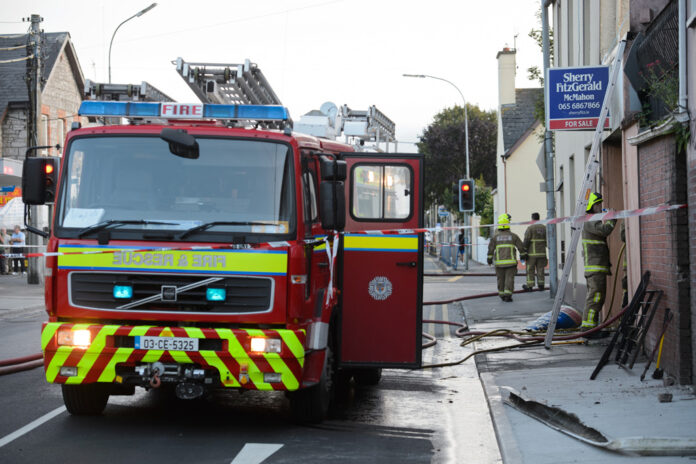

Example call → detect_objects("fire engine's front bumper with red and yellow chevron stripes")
41 322 305 391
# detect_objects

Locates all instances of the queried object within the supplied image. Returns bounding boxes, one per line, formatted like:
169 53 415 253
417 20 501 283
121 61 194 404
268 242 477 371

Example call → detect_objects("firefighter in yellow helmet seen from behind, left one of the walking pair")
488 213 527 302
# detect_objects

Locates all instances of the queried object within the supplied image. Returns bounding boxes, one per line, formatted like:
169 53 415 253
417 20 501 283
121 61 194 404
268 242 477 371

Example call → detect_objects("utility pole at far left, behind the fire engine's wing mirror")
26 14 43 284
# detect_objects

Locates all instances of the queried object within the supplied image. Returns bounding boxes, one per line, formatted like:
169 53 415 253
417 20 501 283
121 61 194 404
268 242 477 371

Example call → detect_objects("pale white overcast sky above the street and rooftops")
0 0 542 152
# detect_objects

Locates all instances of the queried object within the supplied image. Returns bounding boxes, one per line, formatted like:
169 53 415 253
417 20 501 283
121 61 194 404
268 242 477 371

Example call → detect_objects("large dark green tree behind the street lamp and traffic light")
418 105 498 214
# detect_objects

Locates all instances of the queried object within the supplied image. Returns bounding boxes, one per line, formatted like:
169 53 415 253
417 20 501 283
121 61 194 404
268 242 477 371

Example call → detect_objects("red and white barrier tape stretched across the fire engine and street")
0 204 687 258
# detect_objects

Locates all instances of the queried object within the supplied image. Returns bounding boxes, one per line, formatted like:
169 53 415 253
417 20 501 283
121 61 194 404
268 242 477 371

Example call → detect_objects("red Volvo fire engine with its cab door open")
23 101 423 421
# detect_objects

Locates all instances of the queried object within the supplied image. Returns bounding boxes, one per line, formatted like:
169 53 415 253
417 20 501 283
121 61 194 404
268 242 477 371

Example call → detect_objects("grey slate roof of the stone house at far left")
0 32 70 115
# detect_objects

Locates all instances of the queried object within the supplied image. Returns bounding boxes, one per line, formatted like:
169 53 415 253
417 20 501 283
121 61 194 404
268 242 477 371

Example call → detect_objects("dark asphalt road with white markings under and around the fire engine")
0 277 500 464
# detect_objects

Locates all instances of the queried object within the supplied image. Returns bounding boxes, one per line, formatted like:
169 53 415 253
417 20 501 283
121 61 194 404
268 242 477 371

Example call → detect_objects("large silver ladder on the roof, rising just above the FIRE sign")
174 57 292 128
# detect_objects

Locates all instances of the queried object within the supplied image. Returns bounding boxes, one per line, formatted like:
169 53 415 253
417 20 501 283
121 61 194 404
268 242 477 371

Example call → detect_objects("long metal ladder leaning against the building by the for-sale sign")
544 40 626 349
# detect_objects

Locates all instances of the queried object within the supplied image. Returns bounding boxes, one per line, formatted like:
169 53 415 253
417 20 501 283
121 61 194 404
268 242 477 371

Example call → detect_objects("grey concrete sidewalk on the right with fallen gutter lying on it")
462 291 696 464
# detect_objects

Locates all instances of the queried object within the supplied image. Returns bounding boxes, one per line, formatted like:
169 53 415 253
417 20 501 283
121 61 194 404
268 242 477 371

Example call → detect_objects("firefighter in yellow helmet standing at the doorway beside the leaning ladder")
581 193 616 330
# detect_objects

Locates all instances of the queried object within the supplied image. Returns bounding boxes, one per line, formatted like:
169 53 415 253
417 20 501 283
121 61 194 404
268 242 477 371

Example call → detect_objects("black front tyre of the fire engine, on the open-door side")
289 348 333 424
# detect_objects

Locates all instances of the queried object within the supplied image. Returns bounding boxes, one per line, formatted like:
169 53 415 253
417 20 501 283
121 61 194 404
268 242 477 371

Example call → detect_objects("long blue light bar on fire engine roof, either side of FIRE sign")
78 100 290 121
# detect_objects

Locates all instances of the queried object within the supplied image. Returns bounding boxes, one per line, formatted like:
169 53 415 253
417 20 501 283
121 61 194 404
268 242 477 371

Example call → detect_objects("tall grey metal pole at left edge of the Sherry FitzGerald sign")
541 0 558 298
